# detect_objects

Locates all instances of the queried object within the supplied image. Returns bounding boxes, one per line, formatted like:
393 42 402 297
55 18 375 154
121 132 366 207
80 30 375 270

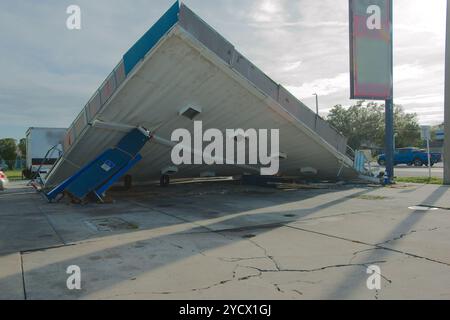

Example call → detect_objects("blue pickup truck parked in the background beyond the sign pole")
378 148 442 167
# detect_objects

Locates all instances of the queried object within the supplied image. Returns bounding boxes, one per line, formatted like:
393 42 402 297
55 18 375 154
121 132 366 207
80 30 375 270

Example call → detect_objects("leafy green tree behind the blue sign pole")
328 101 421 149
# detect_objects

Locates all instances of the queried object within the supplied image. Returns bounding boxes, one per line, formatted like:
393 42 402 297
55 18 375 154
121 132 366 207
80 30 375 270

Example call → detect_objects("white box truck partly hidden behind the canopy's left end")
23 128 67 179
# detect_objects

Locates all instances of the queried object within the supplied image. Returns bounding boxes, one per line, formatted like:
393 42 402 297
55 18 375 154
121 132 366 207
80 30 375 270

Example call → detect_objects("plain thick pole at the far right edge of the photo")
444 0 450 185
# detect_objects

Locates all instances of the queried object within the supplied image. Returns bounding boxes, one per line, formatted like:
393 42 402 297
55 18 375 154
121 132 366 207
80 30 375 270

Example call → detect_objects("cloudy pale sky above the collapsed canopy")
0 0 446 138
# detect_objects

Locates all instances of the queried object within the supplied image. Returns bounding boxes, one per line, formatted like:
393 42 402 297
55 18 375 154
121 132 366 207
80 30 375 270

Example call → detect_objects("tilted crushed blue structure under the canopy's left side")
45 128 151 202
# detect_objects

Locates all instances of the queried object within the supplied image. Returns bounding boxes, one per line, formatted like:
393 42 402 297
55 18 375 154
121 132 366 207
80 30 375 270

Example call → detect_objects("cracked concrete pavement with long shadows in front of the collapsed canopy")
0 182 450 300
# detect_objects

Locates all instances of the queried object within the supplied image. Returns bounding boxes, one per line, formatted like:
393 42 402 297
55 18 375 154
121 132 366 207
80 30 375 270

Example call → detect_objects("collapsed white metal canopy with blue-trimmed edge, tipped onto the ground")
46 2 357 187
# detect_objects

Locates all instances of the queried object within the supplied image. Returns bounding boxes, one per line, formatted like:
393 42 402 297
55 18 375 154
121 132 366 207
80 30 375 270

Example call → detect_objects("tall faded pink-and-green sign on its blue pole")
349 0 395 183
